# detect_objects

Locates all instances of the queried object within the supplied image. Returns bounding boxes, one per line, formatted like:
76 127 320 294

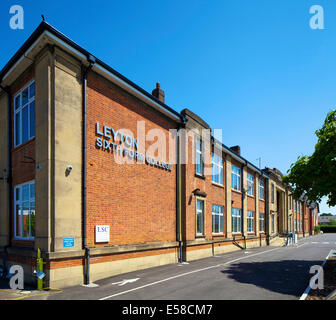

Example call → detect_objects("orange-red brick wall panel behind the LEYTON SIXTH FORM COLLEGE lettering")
87 73 176 247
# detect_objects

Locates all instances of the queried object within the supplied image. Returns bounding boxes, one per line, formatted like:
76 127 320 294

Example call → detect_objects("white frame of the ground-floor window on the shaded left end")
13 180 36 241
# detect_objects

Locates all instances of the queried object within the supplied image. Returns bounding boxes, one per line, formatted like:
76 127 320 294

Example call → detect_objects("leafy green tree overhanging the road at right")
283 110 336 206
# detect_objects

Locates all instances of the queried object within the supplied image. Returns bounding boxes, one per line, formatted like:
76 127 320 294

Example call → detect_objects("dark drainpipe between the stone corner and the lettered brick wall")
82 55 95 284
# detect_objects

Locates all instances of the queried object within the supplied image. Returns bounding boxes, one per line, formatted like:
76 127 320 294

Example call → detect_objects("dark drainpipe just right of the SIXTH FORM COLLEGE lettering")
176 118 186 263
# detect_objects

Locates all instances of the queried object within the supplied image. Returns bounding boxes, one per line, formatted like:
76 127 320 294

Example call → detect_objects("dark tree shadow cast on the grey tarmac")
221 260 322 297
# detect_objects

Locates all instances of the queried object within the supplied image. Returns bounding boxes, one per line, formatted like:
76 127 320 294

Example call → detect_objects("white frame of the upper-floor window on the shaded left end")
13 80 36 148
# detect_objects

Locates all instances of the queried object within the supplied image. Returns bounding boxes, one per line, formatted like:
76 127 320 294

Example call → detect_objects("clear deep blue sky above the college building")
0 0 336 214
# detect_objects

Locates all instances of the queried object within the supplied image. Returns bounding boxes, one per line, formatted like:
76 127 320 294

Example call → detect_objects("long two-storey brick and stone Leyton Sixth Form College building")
0 22 318 287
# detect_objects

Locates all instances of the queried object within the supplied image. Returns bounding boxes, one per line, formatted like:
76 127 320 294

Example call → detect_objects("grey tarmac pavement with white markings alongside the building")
0 234 336 300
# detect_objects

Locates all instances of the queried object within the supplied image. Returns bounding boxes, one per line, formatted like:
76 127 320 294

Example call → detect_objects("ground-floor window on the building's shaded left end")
14 182 35 240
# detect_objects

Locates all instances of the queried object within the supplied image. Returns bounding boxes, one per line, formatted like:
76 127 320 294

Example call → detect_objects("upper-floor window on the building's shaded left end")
14 82 35 147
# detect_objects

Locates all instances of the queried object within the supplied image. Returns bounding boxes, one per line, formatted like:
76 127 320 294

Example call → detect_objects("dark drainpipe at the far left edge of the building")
0 85 13 276
